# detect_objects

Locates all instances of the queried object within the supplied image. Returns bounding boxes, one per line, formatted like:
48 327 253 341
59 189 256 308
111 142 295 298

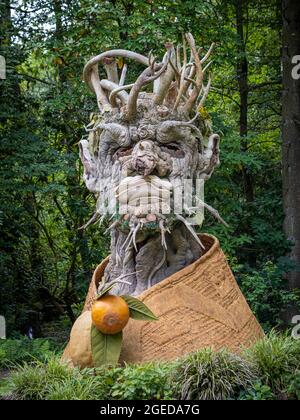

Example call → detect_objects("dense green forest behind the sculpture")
0 0 300 336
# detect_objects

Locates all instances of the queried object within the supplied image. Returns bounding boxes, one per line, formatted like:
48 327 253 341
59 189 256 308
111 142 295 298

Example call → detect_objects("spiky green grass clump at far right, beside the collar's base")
245 331 300 395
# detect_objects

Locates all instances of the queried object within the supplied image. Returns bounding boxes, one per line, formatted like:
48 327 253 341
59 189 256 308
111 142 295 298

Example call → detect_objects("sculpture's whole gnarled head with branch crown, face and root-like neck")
80 34 219 294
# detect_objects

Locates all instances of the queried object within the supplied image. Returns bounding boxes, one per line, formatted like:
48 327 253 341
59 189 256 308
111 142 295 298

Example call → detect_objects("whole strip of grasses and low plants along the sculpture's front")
0 333 300 400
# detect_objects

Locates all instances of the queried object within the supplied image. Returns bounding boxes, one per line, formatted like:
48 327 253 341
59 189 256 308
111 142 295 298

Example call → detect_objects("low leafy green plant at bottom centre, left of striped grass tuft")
111 363 174 400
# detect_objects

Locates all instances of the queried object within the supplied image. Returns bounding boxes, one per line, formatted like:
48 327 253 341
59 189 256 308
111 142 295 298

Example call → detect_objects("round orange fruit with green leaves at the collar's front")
92 295 129 334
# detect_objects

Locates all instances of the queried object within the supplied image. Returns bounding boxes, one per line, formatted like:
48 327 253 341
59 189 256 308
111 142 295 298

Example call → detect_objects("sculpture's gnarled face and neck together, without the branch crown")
81 105 219 295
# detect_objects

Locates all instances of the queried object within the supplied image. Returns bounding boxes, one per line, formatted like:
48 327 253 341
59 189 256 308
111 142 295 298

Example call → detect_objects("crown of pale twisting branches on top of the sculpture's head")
83 33 215 121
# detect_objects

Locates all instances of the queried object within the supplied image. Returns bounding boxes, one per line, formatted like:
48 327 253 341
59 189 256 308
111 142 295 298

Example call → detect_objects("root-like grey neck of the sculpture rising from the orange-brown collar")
105 224 203 295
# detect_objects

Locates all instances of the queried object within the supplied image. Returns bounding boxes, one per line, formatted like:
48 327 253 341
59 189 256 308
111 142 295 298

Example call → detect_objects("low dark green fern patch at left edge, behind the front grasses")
0 337 54 369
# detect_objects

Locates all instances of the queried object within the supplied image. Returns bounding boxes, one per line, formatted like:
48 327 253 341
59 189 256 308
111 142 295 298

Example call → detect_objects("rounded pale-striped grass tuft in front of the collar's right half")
174 349 257 400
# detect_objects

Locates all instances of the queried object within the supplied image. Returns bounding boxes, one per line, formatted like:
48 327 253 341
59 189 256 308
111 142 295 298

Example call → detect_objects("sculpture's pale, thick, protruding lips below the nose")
116 175 173 221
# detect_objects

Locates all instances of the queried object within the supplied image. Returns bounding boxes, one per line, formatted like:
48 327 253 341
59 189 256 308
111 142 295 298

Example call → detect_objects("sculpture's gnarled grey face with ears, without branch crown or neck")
80 99 219 230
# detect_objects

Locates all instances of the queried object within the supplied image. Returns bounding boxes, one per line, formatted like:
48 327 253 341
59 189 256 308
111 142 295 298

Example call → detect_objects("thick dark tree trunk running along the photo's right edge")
282 0 300 323
